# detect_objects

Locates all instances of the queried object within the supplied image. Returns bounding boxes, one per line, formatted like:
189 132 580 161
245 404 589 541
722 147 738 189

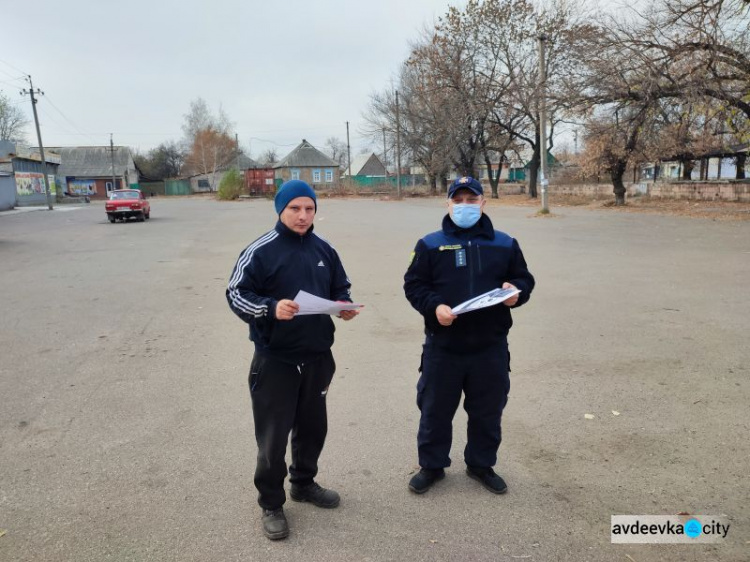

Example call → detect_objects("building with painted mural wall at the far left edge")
0 141 60 209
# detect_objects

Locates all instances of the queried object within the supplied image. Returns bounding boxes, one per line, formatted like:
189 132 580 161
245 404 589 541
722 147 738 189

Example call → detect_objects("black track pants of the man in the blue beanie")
249 351 336 509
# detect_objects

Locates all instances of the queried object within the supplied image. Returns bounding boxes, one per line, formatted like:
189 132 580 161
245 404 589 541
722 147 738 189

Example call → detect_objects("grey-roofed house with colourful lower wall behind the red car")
48 146 140 199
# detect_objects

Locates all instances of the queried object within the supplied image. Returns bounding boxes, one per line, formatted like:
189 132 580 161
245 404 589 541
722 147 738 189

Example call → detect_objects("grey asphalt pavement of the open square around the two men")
0 198 750 562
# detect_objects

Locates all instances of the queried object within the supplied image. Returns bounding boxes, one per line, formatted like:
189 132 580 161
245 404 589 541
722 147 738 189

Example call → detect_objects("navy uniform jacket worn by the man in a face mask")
404 214 534 353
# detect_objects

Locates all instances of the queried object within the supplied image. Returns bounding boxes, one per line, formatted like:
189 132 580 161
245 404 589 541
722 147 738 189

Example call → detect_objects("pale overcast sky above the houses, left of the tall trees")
0 0 465 156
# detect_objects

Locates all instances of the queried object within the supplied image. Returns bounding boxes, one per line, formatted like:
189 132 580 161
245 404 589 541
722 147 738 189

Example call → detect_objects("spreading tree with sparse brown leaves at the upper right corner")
568 0 750 199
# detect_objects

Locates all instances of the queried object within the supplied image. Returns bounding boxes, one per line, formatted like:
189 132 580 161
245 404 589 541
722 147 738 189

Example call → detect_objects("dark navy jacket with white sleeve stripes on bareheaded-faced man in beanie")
226 221 351 364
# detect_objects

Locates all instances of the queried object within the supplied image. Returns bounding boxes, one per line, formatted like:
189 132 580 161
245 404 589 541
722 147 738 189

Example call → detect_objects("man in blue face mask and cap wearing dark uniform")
404 177 534 494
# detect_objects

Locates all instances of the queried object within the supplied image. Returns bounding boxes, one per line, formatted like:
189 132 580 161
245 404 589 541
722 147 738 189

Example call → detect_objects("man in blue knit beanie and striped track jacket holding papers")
226 180 358 540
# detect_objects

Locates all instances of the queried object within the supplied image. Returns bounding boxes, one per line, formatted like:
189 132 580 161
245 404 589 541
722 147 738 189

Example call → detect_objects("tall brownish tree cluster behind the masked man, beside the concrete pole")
366 0 580 196
